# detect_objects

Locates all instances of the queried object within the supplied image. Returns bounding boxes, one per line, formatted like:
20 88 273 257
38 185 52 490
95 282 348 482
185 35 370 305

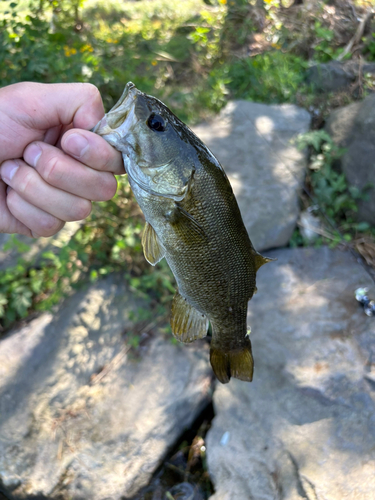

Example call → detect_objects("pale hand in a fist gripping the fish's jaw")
0 82 125 237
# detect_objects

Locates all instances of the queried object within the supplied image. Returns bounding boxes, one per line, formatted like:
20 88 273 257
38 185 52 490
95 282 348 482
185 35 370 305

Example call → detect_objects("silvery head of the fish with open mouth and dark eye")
93 82 199 201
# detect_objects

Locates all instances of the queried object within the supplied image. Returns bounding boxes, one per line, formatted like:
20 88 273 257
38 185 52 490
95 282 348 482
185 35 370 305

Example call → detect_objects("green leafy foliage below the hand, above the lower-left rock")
0 177 174 331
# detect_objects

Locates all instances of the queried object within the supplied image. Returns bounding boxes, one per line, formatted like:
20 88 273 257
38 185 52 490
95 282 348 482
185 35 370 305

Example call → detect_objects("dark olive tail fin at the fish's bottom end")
210 337 254 384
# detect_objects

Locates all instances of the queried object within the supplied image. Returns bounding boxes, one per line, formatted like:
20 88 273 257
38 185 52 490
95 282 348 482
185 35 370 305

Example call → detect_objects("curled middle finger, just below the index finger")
23 142 117 201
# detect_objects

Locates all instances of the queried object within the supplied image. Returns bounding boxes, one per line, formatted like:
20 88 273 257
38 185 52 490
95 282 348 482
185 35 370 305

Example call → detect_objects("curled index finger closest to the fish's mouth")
61 129 125 174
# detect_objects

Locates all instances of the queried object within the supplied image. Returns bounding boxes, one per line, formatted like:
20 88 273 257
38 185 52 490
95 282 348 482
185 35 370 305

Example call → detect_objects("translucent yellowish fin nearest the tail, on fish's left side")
171 291 208 343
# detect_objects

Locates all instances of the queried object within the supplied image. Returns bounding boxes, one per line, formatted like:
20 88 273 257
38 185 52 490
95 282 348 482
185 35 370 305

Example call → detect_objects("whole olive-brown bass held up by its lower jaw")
93 82 273 384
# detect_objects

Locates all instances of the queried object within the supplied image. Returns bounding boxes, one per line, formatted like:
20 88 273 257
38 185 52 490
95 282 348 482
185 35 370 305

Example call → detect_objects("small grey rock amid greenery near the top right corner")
306 60 375 93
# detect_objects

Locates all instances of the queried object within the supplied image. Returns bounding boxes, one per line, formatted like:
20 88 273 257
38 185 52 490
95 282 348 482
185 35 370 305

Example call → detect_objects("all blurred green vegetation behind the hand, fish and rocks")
0 0 375 333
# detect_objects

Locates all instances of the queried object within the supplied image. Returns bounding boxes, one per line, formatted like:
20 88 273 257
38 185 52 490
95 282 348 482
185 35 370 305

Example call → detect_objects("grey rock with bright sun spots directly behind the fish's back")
193 101 310 251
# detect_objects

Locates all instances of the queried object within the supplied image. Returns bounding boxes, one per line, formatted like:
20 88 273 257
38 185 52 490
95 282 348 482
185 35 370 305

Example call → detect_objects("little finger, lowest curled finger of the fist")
7 189 64 238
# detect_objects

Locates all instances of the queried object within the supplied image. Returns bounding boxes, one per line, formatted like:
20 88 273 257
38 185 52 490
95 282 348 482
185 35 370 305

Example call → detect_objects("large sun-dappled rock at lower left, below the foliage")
0 277 212 500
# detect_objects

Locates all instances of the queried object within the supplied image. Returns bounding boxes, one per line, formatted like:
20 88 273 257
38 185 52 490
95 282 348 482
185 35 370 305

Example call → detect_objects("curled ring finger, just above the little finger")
0 160 91 221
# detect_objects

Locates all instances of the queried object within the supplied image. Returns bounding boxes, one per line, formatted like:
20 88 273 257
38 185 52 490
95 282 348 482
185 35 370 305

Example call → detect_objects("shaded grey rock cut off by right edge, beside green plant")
325 94 375 225
